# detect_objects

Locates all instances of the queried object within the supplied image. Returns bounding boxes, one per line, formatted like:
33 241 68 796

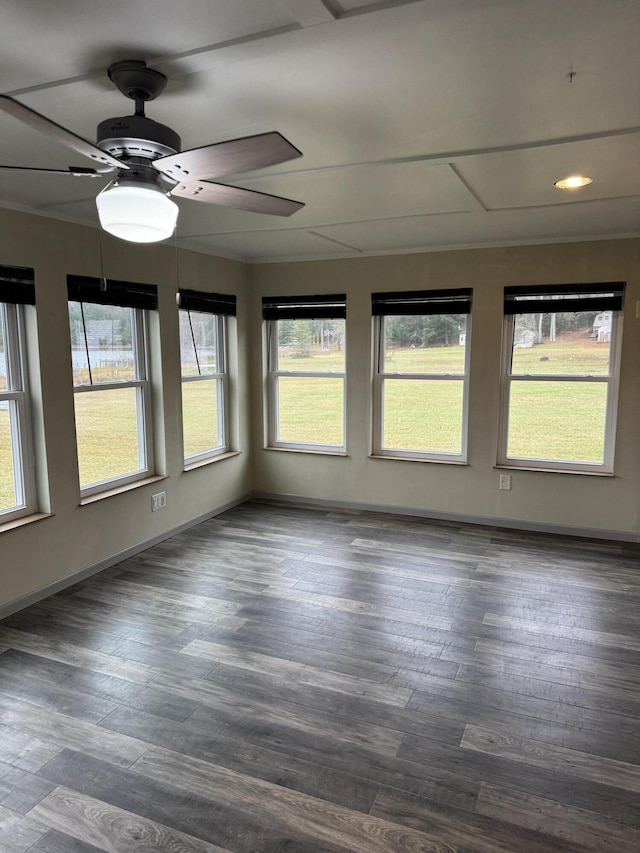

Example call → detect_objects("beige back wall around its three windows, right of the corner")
249 240 640 538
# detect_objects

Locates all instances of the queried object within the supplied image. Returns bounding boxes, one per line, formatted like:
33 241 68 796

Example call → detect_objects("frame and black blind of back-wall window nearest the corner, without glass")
262 294 347 455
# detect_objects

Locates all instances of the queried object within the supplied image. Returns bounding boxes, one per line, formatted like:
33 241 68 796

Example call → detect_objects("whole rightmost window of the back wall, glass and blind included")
498 282 624 473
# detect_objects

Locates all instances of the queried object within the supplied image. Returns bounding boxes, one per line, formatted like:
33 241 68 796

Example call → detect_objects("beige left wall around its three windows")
0 210 251 608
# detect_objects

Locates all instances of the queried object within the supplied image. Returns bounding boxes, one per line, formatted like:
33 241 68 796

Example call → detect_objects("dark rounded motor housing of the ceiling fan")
97 115 181 160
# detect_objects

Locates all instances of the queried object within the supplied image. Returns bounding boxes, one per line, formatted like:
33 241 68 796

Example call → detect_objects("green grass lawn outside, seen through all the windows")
0 337 609 510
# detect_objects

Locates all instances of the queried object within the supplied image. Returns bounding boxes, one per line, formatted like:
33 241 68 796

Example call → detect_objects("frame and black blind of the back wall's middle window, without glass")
371 288 473 465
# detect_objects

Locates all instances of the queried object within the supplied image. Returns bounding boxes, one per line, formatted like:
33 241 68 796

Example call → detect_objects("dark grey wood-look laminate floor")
0 502 640 853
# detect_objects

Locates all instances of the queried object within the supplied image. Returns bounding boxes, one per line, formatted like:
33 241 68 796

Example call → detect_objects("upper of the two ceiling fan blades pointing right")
153 131 302 181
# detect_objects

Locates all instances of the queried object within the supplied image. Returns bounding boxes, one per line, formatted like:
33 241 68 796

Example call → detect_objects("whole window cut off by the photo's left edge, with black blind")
0 266 36 523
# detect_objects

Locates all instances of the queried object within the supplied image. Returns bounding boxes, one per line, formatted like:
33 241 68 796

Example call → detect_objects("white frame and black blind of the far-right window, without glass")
496 282 625 476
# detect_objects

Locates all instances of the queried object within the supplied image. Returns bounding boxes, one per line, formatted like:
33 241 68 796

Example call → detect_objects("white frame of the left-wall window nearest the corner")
179 310 230 462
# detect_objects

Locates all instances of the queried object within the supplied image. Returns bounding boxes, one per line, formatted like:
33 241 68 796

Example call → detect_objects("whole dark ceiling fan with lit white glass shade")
0 60 304 243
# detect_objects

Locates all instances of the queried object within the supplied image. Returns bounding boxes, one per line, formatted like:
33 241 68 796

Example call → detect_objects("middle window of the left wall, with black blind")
68 276 157 496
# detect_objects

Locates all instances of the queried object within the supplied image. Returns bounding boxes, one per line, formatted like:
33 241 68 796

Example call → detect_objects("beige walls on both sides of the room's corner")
0 210 640 609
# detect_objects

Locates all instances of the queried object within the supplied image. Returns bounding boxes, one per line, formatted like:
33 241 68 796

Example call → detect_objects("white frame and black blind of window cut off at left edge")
0 267 37 525
